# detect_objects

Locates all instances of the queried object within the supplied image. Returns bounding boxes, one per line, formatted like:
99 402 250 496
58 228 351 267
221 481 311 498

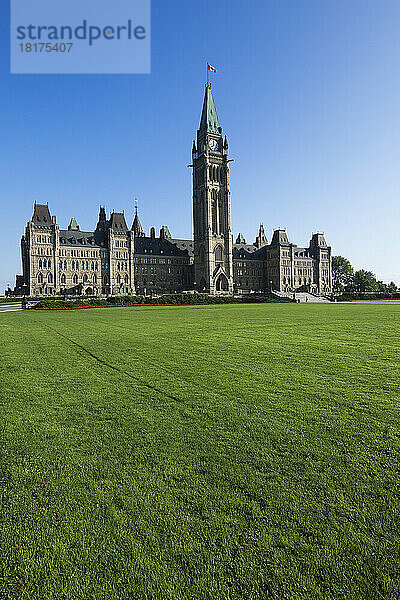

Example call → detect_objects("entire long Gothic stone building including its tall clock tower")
15 84 332 296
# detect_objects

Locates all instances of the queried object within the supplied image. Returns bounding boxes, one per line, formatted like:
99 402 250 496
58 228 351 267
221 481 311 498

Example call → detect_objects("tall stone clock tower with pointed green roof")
192 83 233 294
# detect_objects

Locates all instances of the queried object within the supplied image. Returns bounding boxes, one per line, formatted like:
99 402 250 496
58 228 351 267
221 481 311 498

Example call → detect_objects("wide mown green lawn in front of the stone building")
0 304 400 600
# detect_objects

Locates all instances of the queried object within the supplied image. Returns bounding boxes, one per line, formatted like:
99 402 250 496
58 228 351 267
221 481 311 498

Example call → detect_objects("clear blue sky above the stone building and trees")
0 0 400 290
